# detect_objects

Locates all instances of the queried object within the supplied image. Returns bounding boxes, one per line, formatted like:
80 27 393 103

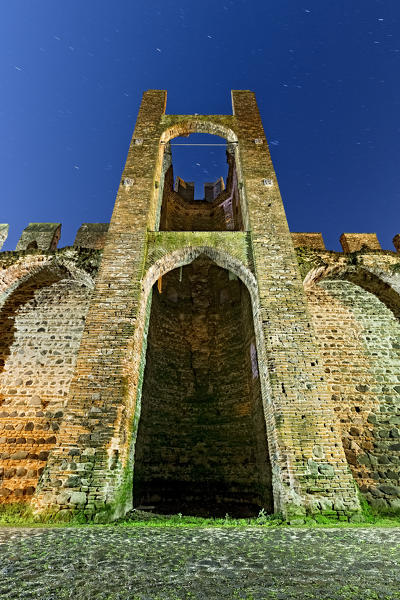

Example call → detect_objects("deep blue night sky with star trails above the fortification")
0 0 400 249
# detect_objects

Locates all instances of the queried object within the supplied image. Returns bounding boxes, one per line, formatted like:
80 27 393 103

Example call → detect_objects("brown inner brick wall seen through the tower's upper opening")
159 147 243 231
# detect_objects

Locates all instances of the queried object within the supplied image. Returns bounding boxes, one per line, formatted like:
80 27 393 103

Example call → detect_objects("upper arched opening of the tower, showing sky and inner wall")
160 133 243 231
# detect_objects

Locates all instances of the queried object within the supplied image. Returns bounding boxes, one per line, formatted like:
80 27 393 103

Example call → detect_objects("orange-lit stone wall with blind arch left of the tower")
0 248 98 503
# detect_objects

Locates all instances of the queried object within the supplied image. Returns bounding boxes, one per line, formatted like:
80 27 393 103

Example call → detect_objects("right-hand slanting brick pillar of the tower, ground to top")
232 91 359 515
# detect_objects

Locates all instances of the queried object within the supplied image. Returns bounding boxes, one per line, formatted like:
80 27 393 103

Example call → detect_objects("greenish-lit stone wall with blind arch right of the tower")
300 252 400 510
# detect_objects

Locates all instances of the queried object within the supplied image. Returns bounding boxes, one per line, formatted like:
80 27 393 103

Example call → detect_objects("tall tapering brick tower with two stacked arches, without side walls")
24 90 360 518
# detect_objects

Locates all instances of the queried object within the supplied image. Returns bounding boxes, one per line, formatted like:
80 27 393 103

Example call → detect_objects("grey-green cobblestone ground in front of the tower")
0 526 400 600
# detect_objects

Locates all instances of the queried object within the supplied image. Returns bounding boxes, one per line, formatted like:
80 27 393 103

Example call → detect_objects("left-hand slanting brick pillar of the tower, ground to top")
34 90 166 514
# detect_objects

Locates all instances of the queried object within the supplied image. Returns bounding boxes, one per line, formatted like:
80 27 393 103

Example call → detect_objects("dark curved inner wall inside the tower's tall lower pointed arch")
133 256 273 517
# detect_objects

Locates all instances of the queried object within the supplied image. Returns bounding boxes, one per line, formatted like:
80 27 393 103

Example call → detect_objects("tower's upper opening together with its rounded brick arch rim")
156 118 248 231
